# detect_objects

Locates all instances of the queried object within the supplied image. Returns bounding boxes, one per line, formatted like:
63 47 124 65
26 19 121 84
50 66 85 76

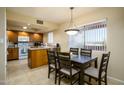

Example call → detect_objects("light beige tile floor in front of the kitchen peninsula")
6 60 79 85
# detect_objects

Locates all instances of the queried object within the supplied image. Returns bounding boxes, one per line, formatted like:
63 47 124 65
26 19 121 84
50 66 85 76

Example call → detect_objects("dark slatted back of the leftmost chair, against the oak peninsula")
47 50 56 67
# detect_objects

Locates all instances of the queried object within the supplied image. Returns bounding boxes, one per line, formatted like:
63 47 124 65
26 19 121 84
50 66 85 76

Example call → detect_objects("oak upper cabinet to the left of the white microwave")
7 31 18 43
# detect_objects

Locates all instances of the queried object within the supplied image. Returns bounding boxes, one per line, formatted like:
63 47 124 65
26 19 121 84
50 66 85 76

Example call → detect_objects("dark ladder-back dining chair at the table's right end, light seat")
84 52 110 85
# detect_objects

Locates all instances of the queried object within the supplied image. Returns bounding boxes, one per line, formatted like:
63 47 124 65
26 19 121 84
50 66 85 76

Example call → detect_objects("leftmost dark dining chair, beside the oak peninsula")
47 50 58 84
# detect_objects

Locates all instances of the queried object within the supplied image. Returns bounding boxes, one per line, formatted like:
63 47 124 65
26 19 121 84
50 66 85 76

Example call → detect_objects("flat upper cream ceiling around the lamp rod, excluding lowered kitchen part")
7 7 98 24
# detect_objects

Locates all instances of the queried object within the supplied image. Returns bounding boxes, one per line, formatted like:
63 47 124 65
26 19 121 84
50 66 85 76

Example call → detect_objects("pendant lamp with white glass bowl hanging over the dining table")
65 7 79 35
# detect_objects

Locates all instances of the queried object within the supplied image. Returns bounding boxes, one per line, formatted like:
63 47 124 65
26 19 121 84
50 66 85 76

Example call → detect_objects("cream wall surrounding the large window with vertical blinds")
44 8 124 84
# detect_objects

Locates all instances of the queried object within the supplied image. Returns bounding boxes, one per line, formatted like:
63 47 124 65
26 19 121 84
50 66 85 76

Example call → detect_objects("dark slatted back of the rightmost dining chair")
99 52 110 78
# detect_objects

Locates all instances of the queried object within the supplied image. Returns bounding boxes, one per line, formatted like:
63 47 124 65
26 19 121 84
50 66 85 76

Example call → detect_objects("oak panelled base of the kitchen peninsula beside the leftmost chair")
28 49 48 68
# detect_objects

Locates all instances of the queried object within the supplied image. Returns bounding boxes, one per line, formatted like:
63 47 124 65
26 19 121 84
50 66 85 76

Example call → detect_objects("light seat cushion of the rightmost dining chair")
85 67 105 79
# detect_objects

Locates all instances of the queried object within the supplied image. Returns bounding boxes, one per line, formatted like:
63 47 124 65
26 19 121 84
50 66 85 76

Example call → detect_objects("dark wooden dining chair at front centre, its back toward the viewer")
58 52 80 85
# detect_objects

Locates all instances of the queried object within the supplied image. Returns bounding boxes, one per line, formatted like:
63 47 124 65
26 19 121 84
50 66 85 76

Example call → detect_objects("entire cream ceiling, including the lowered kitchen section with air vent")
7 7 99 33
